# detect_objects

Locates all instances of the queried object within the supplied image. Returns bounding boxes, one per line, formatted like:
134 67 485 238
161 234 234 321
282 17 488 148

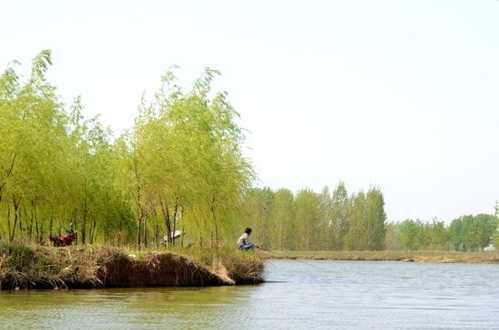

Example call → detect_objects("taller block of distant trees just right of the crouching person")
242 183 386 250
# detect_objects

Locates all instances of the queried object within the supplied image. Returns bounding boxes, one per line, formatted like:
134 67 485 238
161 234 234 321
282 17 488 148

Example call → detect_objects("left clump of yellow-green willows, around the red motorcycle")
0 50 135 243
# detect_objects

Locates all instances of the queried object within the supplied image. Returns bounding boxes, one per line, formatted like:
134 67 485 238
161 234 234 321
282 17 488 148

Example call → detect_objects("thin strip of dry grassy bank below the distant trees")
259 250 499 263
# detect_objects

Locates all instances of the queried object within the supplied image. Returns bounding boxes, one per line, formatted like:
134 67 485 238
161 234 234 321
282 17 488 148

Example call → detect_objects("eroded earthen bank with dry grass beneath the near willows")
0 243 263 290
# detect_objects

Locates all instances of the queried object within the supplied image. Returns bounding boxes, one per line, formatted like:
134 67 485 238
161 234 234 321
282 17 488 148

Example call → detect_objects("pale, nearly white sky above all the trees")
0 0 499 221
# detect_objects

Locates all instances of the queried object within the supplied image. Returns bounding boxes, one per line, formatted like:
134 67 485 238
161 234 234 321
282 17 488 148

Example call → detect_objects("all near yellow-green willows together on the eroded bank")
0 50 253 245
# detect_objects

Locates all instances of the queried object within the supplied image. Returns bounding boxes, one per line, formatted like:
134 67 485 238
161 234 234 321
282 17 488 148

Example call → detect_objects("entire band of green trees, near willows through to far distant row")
0 50 492 253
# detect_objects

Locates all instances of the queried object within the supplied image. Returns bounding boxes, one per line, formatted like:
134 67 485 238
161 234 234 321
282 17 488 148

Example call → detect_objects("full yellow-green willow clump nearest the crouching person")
123 70 252 248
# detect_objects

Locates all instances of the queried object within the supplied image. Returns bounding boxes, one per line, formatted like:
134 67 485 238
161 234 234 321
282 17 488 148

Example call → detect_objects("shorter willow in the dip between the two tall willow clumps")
66 99 127 244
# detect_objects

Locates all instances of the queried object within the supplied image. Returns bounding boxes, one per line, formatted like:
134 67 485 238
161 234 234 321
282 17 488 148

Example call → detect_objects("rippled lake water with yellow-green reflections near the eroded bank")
0 260 499 329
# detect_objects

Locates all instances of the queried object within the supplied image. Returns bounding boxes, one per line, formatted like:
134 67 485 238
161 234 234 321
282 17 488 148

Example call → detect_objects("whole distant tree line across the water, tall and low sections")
242 183 499 251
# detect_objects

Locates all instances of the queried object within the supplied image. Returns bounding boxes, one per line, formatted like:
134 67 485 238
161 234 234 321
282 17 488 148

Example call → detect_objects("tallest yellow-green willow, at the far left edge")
0 51 67 240
